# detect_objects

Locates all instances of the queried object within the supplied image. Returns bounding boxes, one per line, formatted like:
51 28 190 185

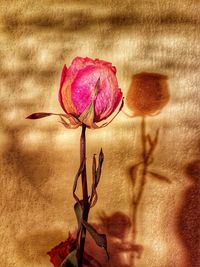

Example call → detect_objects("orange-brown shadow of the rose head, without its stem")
126 72 169 116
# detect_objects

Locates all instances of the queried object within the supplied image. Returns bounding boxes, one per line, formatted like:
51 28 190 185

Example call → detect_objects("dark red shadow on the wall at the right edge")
177 160 200 267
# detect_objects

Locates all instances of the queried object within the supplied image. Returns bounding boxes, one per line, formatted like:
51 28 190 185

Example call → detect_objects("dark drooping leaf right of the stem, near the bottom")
82 221 110 260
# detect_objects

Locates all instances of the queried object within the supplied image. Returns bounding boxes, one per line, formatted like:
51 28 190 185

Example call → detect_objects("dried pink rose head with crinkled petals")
59 57 122 128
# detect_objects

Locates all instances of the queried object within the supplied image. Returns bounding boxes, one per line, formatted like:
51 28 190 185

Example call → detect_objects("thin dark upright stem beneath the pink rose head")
78 124 89 267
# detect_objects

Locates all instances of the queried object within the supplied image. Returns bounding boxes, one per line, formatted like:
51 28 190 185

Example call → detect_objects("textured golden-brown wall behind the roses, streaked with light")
0 0 200 267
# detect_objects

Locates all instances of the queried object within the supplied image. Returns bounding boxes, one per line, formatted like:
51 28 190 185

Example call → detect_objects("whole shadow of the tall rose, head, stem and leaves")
126 72 171 266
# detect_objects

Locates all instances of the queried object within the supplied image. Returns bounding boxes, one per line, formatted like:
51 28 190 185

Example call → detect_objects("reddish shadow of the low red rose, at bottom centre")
86 211 143 267
